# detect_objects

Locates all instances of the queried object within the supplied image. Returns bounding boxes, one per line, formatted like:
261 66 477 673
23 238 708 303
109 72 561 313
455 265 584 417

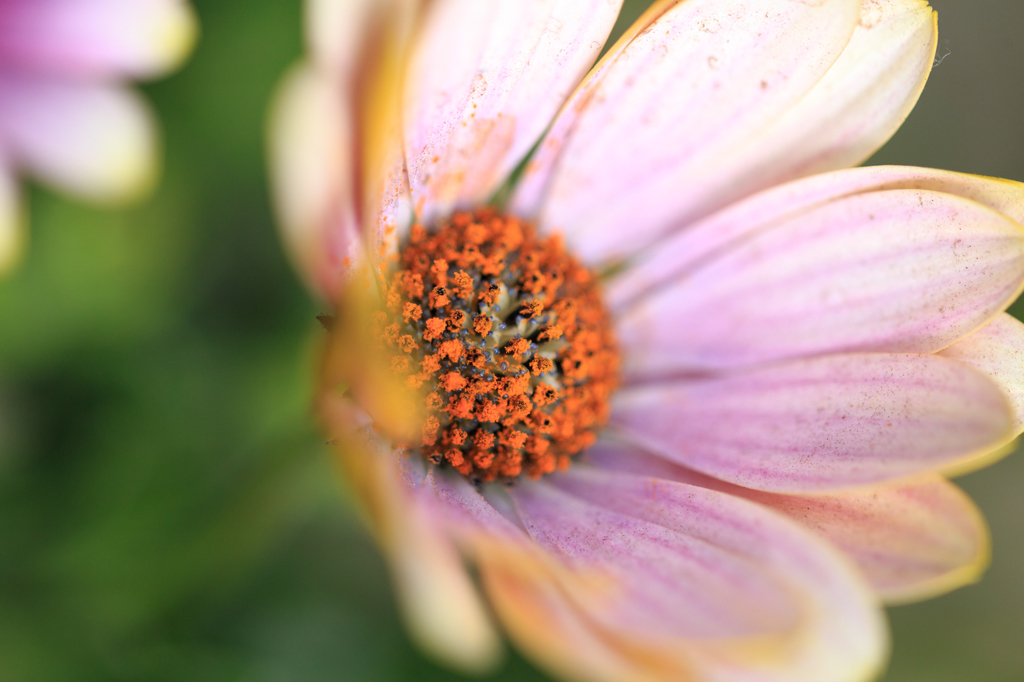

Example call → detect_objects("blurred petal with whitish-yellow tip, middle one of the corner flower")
0 76 158 202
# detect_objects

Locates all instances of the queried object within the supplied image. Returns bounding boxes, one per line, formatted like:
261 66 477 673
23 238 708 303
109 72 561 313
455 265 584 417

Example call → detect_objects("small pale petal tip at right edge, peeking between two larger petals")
940 313 1024 437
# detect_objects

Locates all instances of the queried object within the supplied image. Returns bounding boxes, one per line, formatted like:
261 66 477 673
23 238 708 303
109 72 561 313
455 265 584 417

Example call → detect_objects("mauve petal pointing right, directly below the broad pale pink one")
611 353 1013 493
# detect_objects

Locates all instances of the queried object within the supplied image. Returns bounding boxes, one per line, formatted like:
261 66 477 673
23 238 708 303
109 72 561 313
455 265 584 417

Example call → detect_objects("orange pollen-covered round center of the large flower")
374 209 618 481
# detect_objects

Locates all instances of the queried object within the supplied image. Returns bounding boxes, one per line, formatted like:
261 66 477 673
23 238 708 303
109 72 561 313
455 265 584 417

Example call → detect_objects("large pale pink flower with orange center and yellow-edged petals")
270 0 1024 682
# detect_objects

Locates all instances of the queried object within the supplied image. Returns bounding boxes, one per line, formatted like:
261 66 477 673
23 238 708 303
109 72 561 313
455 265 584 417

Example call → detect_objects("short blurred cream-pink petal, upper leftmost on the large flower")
268 66 362 300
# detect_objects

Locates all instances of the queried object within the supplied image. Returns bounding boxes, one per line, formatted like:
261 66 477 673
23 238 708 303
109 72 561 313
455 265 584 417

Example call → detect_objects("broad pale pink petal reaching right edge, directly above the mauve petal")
616 189 1024 374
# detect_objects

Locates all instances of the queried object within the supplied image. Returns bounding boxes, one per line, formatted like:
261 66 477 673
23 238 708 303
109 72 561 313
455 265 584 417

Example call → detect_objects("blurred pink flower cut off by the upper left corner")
0 0 196 272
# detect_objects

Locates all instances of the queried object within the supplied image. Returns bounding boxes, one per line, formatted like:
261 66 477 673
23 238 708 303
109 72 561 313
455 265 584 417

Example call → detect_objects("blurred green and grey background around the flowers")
0 0 1024 682
